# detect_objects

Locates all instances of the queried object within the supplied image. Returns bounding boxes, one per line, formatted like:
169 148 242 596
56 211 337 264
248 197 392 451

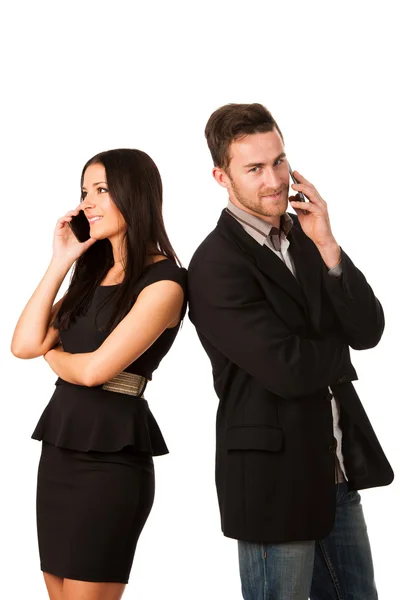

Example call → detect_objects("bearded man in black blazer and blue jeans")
189 104 393 600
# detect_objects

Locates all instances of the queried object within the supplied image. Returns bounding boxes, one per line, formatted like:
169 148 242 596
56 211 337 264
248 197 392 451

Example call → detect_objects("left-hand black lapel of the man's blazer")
218 210 307 311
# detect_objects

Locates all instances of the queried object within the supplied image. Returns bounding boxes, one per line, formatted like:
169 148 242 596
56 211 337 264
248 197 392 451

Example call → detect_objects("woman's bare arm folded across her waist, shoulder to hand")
45 280 184 387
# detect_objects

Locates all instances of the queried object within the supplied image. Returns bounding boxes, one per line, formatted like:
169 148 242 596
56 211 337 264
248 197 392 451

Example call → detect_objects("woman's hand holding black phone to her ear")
53 207 96 266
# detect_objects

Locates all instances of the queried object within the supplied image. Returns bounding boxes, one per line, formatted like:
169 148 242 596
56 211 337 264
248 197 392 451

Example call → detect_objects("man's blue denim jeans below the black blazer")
239 482 378 600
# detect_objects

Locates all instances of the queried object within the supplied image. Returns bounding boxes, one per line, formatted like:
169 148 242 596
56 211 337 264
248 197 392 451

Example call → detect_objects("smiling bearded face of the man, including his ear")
214 129 289 221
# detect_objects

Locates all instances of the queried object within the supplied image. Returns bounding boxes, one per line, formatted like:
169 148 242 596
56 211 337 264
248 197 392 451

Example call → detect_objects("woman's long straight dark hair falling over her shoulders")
53 149 181 329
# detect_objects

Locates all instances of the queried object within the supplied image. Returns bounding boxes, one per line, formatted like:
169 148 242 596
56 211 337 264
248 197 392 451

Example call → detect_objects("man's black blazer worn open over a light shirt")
189 211 393 543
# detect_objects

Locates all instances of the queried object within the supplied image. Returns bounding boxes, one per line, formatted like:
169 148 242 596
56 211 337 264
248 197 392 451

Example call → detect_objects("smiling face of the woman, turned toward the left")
81 163 127 240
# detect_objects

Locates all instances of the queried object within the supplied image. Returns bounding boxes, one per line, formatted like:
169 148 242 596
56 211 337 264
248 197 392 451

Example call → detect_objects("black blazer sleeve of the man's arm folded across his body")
189 254 357 398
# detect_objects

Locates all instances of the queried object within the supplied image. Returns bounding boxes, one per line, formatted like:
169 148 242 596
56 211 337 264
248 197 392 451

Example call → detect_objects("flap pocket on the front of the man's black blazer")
226 425 283 452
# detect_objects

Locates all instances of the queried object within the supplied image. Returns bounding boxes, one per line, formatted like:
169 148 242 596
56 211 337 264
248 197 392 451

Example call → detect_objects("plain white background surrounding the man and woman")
0 0 400 600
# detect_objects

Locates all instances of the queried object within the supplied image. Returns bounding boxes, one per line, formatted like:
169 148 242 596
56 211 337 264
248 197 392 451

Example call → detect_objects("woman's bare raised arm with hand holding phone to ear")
11 210 95 358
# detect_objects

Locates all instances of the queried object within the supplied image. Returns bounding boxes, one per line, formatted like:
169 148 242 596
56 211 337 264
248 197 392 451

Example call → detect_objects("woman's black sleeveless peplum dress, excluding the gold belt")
32 259 187 583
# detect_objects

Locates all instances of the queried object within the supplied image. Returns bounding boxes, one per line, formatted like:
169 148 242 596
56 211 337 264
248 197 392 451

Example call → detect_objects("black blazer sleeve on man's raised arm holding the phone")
324 250 385 350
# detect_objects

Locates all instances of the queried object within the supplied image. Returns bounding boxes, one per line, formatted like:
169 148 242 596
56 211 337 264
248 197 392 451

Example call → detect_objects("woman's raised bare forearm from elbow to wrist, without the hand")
11 260 71 358
